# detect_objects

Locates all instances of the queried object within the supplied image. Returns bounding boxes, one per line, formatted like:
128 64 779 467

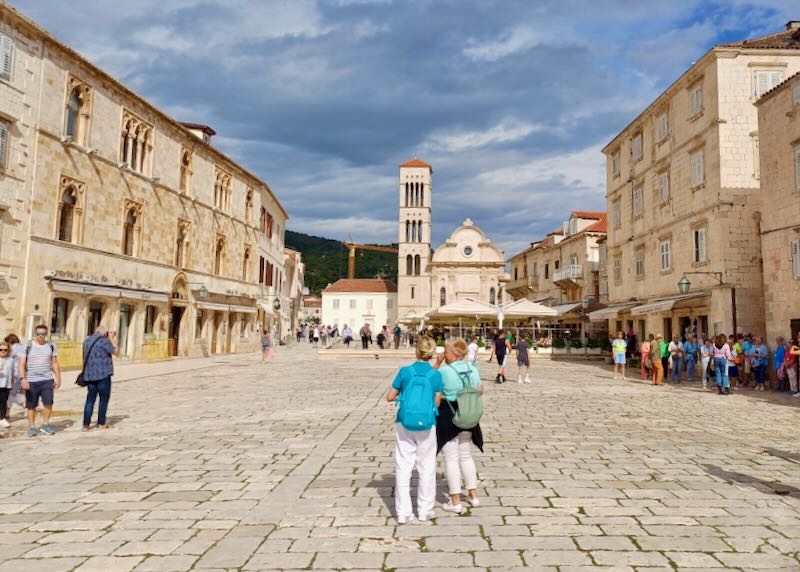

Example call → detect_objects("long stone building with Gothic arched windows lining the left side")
0 4 287 366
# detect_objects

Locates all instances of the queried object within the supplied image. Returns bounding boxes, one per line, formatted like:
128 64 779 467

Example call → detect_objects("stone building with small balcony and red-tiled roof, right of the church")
507 211 607 331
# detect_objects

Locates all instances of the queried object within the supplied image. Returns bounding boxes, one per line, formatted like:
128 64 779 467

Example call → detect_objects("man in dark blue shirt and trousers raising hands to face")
83 326 117 431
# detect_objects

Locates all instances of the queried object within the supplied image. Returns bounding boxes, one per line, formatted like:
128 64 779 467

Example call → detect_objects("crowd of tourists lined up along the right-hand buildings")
611 332 800 398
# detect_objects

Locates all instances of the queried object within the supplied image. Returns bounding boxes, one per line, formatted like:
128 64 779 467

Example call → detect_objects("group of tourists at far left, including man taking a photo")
0 324 117 437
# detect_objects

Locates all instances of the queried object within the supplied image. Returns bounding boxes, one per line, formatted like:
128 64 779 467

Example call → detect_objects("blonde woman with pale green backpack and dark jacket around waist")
434 338 483 514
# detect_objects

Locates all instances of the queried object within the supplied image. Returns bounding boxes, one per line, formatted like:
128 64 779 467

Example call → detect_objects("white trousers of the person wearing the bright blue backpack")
394 423 436 518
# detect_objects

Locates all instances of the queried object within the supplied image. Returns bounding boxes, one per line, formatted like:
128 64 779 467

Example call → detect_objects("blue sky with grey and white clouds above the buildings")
10 0 800 255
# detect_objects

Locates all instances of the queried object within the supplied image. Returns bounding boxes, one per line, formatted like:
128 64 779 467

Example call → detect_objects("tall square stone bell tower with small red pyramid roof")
397 159 433 320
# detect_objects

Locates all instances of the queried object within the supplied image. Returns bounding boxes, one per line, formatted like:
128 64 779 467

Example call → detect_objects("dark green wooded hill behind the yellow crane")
286 230 397 295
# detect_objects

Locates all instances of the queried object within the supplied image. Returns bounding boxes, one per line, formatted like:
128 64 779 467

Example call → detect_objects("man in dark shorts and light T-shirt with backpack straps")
19 324 61 437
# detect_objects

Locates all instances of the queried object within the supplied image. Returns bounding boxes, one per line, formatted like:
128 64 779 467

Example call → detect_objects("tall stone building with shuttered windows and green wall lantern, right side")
595 22 800 339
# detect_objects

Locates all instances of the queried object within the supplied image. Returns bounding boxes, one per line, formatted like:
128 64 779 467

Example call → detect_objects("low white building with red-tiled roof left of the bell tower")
322 278 397 332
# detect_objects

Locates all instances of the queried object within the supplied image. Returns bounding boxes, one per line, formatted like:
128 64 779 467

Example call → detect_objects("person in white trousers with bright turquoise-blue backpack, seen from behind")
386 336 442 524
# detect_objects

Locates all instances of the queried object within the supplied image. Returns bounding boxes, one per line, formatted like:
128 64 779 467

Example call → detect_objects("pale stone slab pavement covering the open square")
0 346 800 572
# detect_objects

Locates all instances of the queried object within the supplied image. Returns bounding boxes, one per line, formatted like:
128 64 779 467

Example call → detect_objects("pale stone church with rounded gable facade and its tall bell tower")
397 159 507 324
